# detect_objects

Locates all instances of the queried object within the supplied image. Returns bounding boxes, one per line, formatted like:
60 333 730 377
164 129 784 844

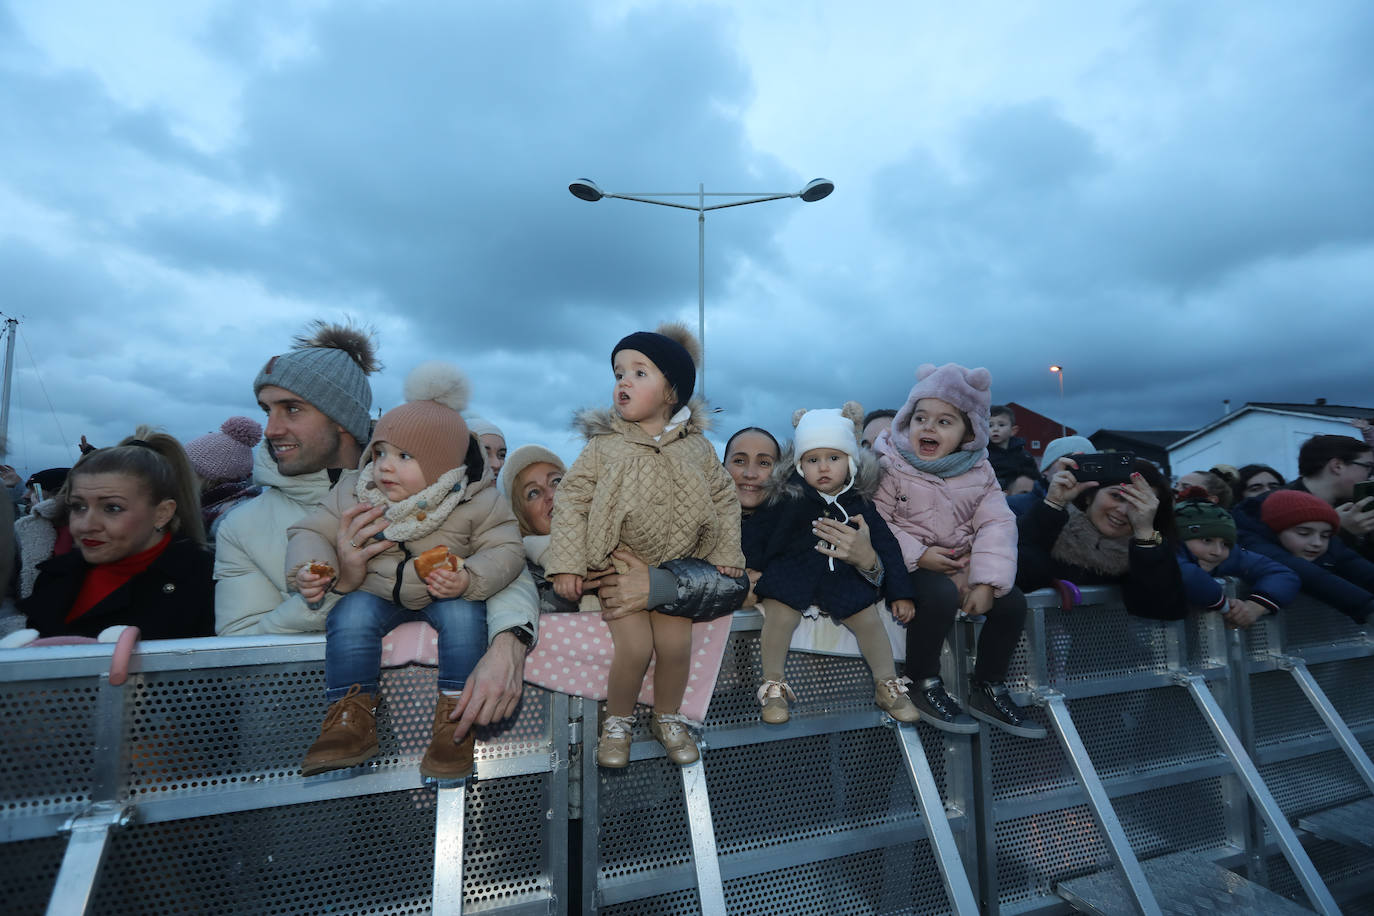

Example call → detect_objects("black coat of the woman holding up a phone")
1017 500 1187 621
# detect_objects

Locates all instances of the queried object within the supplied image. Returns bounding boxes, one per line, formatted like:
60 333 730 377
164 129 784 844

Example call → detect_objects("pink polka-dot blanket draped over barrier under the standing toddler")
525 612 730 722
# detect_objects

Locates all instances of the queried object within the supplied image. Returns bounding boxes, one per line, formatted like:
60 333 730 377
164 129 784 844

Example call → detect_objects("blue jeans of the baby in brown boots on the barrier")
324 591 486 703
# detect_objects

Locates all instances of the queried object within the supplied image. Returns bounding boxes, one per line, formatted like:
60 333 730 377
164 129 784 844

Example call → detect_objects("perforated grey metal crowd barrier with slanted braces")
0 589 1374 916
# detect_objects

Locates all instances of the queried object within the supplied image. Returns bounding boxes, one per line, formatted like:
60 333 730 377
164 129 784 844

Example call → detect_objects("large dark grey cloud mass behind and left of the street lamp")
129 3 797 346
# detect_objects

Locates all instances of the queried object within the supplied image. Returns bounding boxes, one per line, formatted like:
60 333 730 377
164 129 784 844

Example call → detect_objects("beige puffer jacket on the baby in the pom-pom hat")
286 471 525 611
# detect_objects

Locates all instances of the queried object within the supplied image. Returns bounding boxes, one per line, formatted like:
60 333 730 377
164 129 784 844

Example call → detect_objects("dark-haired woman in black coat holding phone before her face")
1017 459 1187 621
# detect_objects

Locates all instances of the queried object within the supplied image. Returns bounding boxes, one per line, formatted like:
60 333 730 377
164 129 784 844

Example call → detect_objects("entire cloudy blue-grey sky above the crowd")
0 0 1374 470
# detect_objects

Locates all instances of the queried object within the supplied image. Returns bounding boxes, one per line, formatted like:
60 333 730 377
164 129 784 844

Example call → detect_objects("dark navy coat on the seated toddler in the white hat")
743 471 915 621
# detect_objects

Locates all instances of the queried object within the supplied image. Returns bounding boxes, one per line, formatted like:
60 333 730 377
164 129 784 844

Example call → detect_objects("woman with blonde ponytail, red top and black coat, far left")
21 427 214 639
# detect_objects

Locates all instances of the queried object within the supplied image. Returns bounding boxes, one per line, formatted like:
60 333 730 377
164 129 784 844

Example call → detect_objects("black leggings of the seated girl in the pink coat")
907 570 1026 684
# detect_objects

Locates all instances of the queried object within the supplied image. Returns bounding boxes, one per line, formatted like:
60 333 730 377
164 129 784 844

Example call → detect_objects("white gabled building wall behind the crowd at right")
1169 411 1360 481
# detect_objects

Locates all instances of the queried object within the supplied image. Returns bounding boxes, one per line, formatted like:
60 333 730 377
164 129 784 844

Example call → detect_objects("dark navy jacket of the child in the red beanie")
1231 493 1374 623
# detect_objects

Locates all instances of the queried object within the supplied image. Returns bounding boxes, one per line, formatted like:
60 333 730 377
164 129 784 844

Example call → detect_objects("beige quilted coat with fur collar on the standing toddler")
544 401 745 575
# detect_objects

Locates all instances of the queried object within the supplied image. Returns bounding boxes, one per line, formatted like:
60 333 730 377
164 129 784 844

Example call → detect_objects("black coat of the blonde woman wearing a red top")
19 538 214 640
